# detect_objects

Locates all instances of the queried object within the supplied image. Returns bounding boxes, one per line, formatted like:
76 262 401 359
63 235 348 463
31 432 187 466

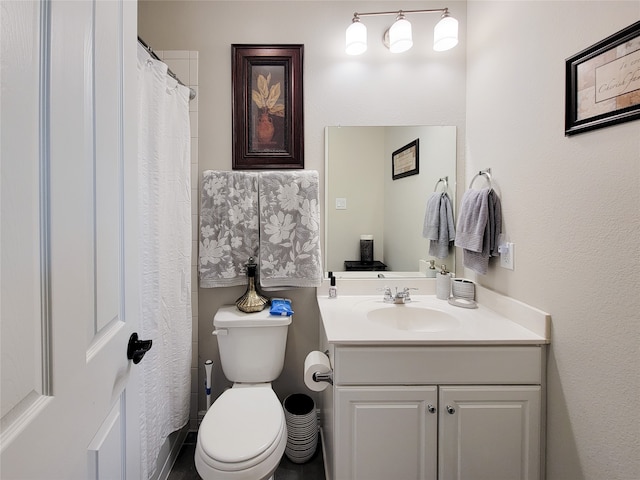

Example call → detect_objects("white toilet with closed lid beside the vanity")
195 305 291 480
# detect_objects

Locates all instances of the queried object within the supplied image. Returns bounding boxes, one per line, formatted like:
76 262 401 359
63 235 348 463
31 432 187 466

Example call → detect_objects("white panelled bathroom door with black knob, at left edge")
0 0 140 480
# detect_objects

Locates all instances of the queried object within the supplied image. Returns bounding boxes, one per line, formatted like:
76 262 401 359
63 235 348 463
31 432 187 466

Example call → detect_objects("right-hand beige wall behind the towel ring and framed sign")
466 0 640 480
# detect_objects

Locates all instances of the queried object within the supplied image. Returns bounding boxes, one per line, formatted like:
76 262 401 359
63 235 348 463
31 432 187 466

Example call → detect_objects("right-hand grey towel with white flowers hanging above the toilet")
258 170 323 289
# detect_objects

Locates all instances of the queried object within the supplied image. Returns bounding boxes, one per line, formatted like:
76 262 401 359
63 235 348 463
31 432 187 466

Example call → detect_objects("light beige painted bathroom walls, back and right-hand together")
139 0 640 480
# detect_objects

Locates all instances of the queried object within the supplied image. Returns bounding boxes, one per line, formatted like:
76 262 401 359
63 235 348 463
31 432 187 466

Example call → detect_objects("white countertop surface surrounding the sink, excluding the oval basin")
317 278 551 345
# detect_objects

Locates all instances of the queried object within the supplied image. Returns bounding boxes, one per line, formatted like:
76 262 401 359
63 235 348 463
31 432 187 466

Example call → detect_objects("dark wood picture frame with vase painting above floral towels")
231 44 304 170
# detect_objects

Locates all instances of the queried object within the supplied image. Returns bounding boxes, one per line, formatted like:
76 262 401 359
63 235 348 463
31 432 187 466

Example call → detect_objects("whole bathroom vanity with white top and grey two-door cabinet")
318 279 550 480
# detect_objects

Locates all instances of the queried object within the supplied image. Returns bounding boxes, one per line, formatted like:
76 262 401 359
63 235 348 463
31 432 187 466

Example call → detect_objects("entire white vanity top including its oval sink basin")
318 290 549 346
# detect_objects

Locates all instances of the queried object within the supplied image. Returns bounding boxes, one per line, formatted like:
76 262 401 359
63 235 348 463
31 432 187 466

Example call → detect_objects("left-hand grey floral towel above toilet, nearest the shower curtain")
199 170 258 288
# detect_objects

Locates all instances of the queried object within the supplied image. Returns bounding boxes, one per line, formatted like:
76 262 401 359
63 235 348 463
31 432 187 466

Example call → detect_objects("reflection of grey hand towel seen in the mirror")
422 193 456 258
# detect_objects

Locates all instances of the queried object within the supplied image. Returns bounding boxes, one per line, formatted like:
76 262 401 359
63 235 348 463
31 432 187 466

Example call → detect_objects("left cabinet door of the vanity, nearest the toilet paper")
335 386 438 480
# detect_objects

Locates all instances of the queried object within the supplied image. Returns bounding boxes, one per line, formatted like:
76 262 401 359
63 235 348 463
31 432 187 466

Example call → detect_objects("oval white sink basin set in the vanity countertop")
367 305 460 333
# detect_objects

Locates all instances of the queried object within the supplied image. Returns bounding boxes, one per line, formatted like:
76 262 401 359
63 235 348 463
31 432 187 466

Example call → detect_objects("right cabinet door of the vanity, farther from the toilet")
438 386 541 480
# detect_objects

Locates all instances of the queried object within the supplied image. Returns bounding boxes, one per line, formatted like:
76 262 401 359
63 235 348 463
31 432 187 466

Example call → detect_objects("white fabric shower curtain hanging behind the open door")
138 45 191 479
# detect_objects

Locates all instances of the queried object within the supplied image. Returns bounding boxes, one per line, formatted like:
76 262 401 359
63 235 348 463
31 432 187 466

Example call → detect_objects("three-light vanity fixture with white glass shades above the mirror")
345 8 458 55
